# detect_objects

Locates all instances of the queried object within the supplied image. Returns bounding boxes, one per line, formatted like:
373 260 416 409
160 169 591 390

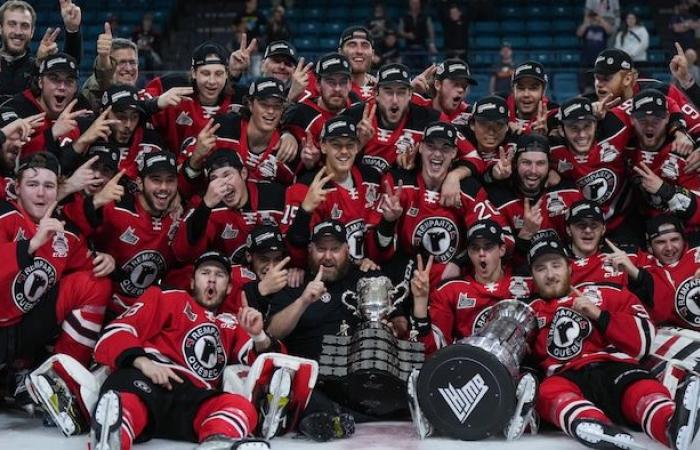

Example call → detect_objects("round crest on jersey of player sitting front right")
547 307 592 361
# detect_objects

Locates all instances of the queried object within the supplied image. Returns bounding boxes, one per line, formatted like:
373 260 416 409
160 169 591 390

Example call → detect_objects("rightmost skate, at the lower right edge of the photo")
668 375 700 450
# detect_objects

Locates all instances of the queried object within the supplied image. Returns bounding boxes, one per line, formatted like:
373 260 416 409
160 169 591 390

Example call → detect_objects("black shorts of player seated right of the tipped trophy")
556 361 656 425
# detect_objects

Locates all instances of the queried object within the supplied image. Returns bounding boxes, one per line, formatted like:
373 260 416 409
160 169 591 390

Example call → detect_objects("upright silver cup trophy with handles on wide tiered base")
319 276 425 417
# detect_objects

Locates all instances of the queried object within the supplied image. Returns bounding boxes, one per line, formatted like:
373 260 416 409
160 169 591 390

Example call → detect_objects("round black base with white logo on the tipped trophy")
417 344 516 441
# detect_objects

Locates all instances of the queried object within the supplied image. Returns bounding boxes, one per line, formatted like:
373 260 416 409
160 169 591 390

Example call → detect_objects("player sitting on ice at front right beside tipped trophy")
528 239 700 450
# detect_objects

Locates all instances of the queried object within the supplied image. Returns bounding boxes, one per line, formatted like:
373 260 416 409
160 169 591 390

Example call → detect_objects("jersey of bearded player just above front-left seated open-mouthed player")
63 193 178 310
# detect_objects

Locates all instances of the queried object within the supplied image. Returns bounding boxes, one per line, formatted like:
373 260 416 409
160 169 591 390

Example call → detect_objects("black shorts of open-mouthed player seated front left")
101 367 220 442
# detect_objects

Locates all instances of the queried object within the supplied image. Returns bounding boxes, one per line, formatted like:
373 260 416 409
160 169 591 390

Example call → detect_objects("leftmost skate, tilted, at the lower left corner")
27 371 88 436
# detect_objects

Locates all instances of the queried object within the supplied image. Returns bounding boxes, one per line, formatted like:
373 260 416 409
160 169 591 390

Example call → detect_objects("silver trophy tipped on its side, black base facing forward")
409 300 537 441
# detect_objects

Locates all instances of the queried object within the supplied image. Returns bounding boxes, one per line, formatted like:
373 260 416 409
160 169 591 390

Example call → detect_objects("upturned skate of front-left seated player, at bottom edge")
90 391 122 450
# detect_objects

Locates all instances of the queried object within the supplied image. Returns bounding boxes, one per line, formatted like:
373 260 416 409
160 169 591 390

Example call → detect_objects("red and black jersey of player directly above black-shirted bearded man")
282 164 381 267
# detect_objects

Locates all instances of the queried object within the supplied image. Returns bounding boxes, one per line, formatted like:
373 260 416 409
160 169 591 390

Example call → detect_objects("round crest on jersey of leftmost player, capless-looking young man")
12 258 56 313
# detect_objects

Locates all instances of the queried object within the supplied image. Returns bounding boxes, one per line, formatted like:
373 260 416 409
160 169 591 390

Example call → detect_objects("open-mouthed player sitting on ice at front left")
91 252 280 450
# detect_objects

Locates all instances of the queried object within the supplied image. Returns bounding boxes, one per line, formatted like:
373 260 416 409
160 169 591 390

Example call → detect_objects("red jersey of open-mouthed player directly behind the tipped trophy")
420 271 532 355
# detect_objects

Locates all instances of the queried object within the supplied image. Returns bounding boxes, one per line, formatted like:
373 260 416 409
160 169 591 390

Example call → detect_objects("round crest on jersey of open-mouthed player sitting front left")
182 323 226 380
